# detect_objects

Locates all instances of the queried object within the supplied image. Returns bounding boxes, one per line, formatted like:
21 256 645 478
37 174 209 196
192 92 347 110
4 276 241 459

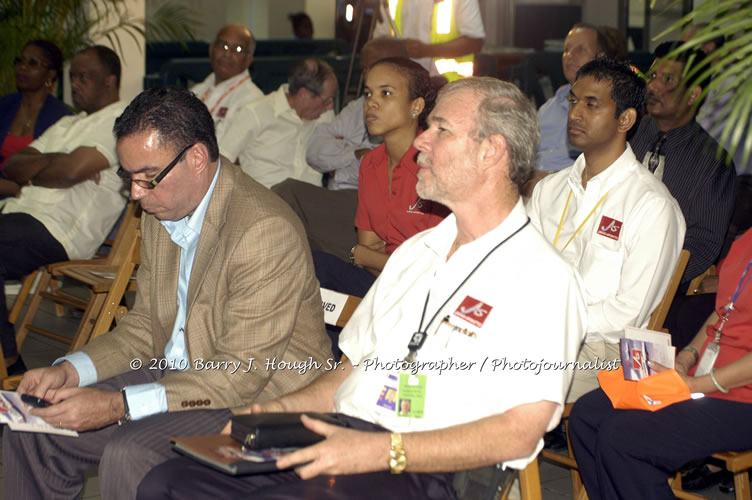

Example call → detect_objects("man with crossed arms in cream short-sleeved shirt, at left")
0 45 126 374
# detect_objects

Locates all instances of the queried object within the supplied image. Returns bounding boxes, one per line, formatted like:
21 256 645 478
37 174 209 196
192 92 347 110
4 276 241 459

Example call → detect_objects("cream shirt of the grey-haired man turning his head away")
227 83 334 188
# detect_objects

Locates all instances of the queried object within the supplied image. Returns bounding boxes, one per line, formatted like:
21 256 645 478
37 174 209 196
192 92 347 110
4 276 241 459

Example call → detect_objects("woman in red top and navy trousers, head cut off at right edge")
569 230 752 500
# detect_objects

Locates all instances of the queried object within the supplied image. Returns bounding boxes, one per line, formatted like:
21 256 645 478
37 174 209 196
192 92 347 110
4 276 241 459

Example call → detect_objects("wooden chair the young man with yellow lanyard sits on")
541 250 690 499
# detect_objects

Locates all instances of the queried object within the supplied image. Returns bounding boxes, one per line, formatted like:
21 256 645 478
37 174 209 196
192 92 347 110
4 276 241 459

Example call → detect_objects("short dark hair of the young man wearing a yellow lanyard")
575 57 647 130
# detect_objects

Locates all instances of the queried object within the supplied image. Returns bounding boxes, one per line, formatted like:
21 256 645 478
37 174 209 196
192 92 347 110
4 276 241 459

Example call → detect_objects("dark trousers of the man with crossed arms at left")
0 213 68 358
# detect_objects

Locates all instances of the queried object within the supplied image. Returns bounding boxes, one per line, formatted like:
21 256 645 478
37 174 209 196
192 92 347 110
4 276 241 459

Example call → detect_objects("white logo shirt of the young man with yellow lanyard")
528 144 686 344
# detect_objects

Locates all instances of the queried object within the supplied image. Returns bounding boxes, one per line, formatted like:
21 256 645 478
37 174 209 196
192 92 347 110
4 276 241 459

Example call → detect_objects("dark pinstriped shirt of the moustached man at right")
629 115 736 282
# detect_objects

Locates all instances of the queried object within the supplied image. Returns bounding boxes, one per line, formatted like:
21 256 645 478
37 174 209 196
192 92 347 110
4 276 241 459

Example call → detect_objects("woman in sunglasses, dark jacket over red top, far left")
0 40 71 195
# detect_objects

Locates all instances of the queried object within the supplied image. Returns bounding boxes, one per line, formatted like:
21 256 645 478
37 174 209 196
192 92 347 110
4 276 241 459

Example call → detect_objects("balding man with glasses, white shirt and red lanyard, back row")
191 24 264 160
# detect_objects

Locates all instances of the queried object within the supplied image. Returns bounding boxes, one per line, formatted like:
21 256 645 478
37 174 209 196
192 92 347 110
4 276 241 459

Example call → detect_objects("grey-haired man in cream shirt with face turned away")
222 59 337 187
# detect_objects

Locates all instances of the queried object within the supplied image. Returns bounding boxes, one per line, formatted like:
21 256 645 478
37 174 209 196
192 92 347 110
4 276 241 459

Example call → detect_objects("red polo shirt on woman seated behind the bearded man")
355 144 449 255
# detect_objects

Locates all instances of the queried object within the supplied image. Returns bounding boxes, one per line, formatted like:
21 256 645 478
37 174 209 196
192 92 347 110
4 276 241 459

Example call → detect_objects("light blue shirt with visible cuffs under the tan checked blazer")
62 161 222 420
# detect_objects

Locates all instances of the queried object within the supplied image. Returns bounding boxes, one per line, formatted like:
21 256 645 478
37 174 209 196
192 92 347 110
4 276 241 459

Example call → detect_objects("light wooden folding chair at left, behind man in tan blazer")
0 202 141 378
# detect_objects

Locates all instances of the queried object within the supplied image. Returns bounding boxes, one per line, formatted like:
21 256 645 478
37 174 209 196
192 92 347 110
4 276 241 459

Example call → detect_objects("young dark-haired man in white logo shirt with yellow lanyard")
529 58 686 402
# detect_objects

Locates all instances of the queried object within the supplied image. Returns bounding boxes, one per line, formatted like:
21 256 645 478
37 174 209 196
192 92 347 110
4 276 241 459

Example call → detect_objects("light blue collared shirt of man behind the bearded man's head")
535 84 580 172
